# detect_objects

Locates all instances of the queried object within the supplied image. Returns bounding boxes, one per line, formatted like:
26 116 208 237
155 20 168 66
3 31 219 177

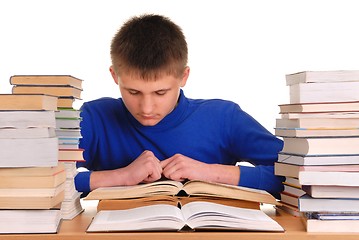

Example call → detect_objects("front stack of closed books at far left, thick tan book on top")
0 94 66 233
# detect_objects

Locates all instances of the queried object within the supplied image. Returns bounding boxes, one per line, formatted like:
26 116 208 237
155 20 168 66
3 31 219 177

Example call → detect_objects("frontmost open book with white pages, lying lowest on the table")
87 202 284 232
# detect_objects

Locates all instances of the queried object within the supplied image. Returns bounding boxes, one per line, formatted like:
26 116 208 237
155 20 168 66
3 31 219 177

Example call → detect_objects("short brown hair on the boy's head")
111 14 188 79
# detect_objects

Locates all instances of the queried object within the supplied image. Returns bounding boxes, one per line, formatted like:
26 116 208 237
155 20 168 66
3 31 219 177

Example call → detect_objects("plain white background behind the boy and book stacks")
0 0 359 131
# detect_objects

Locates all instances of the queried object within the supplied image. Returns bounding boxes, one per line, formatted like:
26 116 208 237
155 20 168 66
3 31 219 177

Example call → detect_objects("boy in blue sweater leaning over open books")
75 14 283 197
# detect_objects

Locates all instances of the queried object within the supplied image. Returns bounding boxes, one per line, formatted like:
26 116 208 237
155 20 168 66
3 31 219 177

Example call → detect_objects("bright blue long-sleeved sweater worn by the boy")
75 91 283 197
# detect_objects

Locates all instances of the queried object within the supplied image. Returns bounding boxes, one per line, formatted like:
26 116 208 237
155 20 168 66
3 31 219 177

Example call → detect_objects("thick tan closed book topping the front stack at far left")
0 94 57 111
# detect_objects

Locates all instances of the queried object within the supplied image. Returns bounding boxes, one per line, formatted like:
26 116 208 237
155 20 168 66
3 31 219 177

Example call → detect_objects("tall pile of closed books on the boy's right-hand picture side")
275 71 359 232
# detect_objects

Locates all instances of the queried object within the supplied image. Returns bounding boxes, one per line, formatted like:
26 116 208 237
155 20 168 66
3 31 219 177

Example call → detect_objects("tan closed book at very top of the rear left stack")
10 75 83 89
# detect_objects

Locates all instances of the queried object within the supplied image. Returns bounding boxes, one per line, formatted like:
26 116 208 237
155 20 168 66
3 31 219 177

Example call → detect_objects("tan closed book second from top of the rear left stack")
12 85 82 99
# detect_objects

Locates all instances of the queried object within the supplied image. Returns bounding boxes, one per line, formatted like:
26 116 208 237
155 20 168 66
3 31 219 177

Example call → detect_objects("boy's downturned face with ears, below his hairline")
110 67 189 126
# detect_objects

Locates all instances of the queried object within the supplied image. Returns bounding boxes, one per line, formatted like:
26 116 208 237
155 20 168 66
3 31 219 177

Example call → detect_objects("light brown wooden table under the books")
0 202 359 240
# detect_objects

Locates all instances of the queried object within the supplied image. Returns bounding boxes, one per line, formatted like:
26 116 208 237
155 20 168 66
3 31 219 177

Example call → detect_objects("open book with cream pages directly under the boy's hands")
86 180 277 205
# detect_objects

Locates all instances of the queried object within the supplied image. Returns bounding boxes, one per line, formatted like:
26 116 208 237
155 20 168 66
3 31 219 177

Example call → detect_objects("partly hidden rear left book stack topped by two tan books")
10 75 84 219
